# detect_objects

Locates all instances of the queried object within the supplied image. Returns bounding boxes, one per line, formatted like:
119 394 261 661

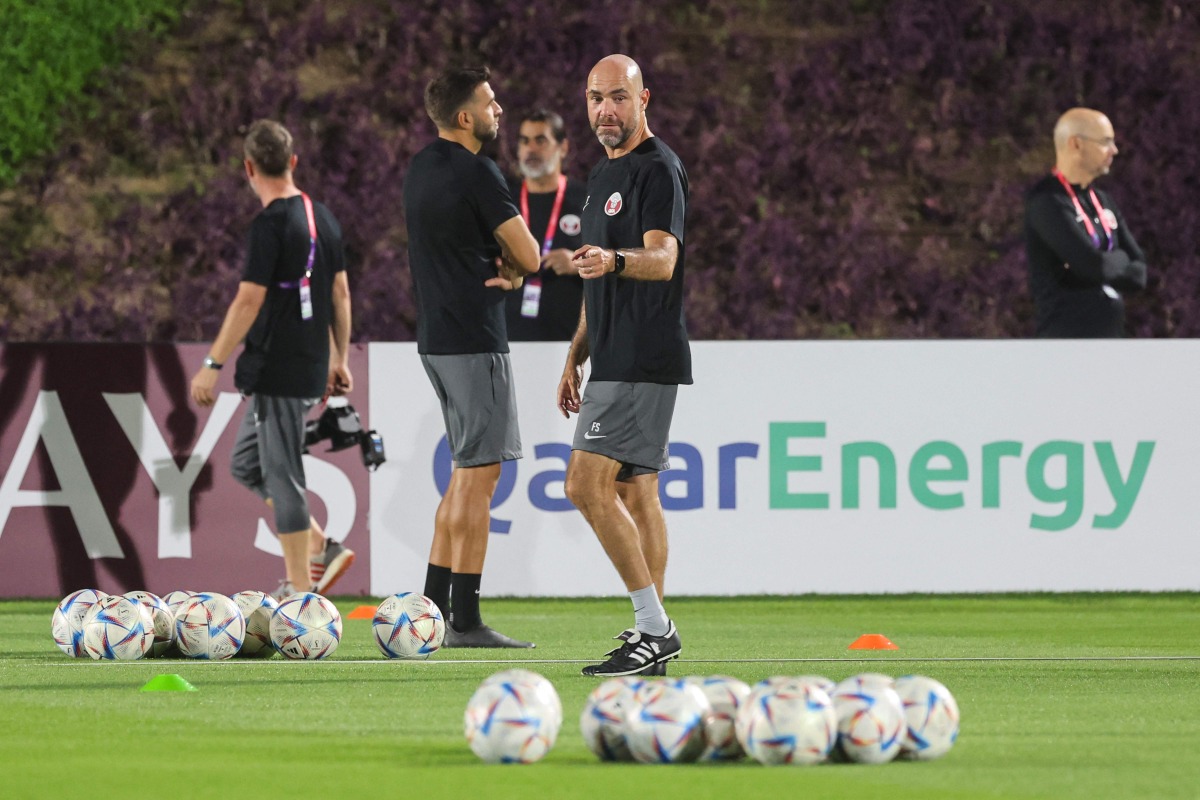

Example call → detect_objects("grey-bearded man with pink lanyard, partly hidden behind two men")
504 108 587 342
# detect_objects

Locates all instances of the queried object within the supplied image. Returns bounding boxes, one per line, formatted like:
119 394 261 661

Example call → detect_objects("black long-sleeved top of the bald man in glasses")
1025 175 1146 338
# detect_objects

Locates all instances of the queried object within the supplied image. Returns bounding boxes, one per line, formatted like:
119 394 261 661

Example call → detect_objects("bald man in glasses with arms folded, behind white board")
1025 108 1146 338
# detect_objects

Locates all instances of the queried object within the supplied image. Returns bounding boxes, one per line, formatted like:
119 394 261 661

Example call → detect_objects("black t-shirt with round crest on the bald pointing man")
583 137 691 384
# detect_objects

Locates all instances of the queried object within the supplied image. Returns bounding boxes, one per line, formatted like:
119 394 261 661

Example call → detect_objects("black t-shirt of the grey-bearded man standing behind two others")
504 179 588 342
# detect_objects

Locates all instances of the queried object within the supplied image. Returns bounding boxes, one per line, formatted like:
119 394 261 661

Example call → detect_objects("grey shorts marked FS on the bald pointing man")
571 380 679 481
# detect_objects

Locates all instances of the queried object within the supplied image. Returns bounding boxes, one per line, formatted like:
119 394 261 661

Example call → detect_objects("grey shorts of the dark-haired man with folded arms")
421 353 521 467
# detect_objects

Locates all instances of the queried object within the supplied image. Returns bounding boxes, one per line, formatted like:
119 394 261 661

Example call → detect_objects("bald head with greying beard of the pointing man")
584 54 653 158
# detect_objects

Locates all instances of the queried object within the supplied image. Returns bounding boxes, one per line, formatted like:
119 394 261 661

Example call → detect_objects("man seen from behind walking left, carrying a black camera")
192 120 354 600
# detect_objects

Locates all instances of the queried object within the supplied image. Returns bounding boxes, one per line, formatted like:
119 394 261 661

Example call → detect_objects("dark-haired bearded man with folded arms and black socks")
404 67 540 648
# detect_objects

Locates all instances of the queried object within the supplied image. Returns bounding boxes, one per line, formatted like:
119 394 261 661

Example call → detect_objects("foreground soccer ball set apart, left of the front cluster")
463 669 563 764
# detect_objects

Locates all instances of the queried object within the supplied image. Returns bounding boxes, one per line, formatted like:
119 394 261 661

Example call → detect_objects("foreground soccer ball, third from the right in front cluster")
736 681 838 765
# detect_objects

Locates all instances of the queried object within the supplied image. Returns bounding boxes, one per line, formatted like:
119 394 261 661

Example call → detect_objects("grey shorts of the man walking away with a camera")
230 395 317 534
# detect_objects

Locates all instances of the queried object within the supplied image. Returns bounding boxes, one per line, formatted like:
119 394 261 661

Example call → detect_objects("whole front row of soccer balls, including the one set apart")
466 669 959 765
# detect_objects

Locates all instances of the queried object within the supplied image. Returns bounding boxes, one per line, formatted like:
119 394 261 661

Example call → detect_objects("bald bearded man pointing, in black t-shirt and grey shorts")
558 55 691 678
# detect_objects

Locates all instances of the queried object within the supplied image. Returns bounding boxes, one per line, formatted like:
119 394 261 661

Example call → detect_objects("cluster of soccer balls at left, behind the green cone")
50 589 342 661
